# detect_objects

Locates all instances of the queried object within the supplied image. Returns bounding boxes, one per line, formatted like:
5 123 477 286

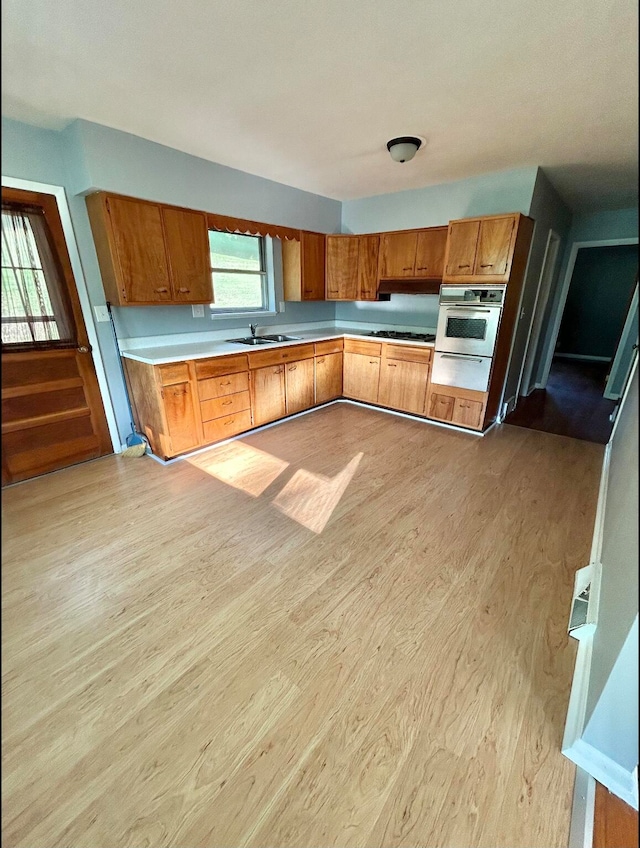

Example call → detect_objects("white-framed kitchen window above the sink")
209 230 275 317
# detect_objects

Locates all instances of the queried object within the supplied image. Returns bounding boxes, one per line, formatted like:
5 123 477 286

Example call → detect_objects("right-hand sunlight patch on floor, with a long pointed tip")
272 453 364 533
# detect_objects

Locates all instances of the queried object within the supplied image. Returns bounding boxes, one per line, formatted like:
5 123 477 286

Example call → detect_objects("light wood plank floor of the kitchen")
2 404 603 848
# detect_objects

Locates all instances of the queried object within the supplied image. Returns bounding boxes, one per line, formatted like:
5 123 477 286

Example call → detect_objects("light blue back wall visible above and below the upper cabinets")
336 167 538 329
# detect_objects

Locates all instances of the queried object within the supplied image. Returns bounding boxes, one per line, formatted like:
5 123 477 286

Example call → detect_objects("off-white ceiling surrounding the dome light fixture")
2 0 638 209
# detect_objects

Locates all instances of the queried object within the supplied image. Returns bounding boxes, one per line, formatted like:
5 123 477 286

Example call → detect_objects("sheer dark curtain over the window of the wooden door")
2 201 76 348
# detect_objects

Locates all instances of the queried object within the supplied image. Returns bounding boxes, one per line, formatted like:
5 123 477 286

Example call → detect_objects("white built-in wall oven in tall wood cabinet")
431 285 506 392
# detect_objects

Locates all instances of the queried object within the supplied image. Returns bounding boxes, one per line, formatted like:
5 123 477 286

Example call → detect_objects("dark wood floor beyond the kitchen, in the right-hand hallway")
506 358 616 445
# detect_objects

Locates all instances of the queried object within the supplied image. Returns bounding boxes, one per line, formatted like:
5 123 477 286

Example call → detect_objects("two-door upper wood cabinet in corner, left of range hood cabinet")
326 235 380 300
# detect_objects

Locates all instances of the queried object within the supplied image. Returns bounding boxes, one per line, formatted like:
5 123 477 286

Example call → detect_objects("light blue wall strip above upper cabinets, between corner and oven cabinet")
342 166 538 233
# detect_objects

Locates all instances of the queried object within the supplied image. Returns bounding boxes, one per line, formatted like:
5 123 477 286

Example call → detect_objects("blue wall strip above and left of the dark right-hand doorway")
533 206 638 381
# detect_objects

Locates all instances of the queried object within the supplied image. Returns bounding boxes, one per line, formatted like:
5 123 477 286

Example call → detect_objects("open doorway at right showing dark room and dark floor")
505 242 638 444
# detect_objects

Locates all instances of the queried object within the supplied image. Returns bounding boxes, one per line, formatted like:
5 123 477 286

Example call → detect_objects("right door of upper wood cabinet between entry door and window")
162 207 213 303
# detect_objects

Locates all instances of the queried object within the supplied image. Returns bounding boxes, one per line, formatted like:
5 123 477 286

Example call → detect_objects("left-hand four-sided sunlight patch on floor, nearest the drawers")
188 442 289 498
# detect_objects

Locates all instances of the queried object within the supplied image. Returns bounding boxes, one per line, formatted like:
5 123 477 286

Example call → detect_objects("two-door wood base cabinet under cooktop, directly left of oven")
378 344 431 415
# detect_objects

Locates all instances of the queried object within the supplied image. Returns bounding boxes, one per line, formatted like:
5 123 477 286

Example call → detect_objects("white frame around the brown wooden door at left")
2 176 122 453
